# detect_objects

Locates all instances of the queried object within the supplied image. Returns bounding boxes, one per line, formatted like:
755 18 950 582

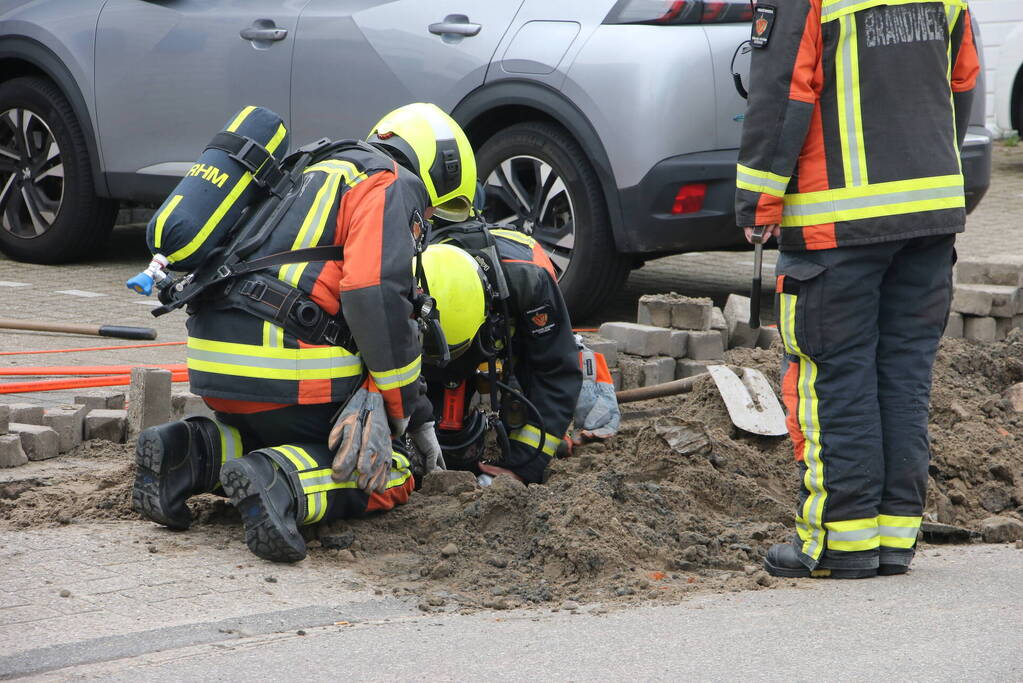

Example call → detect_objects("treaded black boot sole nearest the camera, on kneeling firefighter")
220 459 306 562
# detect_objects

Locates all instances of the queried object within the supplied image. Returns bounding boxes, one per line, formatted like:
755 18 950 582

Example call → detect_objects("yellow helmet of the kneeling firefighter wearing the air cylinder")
366 102 476 223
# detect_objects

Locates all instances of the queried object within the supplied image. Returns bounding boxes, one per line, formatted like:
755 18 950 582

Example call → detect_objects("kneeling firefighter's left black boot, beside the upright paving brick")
131 420 220 531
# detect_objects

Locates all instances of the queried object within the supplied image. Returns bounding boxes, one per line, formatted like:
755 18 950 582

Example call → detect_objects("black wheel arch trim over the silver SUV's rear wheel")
451 80 625 248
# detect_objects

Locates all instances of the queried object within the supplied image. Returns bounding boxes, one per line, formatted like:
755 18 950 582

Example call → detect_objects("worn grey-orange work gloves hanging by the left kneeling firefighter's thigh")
327 388 392 493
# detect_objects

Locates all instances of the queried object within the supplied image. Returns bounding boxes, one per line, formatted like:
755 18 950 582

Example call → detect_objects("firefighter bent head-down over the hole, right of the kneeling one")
413 229 582 484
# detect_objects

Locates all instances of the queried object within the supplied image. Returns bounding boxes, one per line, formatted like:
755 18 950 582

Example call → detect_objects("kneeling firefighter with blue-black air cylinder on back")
129 104 476 561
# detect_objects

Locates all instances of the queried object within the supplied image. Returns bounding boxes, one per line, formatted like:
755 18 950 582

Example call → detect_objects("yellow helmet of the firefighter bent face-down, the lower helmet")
422 244 488 362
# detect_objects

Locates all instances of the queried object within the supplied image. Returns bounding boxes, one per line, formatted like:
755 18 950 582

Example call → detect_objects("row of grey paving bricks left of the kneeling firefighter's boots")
0 368 213 468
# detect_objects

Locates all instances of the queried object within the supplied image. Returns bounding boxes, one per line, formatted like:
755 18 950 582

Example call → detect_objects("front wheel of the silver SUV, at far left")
0 78 118 264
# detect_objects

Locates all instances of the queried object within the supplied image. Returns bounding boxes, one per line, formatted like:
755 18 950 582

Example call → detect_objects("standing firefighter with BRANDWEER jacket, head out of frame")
736 0 979 578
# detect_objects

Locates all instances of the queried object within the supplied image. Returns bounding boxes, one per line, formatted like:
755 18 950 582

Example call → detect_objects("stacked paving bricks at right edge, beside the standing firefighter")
945 256 1023 342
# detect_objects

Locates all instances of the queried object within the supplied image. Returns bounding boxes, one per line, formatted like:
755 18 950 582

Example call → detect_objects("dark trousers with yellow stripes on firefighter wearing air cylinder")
209 403 415 525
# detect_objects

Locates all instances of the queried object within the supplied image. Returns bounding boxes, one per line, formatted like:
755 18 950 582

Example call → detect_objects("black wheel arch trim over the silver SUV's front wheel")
0 36 109 197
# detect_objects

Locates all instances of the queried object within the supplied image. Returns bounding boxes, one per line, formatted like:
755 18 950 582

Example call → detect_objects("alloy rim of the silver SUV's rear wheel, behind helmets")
484 154 576 278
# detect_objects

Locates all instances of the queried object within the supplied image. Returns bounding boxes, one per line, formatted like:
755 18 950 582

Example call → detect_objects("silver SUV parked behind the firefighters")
0 0 989 316
